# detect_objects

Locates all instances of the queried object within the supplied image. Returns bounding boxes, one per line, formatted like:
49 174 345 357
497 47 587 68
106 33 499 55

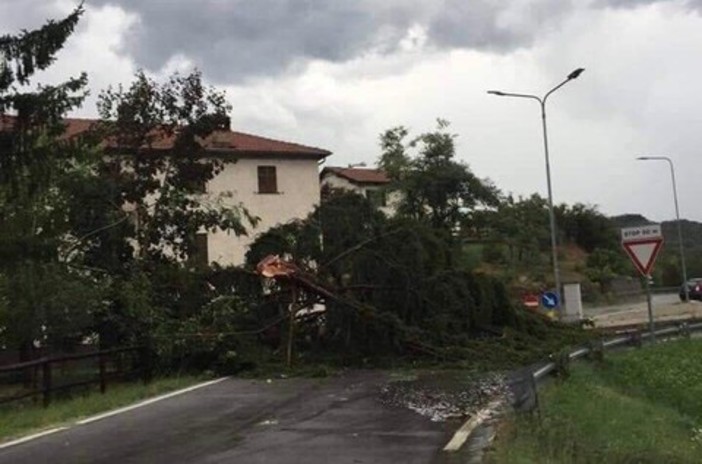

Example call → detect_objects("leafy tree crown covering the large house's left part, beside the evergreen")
84 72 256 269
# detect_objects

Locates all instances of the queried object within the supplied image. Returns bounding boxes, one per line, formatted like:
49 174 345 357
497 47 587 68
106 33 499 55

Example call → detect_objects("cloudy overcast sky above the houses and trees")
0 0 702 220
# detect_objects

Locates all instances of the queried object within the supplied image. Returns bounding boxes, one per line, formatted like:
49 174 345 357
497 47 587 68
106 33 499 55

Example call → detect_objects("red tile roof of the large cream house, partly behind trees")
0 116 331 158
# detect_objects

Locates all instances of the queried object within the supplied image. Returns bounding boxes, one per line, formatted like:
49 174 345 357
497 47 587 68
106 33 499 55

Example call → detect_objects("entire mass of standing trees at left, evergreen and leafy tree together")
0 6 260 365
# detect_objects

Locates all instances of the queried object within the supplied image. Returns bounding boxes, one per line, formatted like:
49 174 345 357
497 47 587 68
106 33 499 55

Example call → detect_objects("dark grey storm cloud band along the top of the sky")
84 0 569 81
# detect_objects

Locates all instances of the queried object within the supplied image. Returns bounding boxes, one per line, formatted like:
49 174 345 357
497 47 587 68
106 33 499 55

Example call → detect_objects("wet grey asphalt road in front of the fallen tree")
0 371 456 464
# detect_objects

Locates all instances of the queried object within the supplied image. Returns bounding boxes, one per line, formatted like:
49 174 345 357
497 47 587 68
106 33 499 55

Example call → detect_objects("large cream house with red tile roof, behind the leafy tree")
0 116 331 266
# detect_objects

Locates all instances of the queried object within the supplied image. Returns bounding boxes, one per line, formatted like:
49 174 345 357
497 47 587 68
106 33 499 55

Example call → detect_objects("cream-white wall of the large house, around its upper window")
207 158 320 265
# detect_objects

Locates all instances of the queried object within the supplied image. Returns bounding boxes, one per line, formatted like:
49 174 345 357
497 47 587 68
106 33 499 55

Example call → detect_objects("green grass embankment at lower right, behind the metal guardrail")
490 340 702 464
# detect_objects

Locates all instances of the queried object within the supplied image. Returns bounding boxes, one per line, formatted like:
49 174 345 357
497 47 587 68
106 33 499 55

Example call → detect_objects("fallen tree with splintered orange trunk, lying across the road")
247 191 592 363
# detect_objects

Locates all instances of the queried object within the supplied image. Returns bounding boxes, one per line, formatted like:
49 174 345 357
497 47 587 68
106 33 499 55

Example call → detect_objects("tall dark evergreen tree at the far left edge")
0 5 99 358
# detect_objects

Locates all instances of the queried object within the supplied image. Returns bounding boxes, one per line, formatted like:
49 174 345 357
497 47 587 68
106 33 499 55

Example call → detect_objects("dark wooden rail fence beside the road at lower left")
0 347 151 407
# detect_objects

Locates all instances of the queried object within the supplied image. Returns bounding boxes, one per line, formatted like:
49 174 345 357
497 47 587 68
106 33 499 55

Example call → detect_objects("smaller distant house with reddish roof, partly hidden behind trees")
319 166 397 215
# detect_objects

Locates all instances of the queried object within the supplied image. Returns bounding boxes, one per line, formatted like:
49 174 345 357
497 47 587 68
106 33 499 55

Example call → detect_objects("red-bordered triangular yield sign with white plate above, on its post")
622 224 663 341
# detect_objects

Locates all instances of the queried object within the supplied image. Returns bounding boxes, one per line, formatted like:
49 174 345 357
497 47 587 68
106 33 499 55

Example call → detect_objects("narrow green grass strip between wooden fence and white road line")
0 376 205 441
